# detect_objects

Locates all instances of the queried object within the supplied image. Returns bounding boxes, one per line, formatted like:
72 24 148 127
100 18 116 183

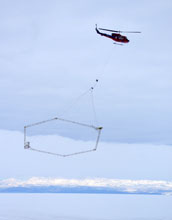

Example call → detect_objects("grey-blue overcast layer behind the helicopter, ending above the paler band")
0 0 172 144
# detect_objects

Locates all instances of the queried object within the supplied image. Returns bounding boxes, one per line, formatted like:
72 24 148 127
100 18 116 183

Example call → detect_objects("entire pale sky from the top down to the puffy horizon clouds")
0 0 172 186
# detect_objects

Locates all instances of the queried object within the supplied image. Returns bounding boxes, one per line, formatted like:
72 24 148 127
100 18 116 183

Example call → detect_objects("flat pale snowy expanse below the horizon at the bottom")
0 194 172 220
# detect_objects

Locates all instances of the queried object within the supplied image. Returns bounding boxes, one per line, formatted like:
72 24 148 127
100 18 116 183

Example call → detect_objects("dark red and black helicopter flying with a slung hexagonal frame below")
95 24 141 45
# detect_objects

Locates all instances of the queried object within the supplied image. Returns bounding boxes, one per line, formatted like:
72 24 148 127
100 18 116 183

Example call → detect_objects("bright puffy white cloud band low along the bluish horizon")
0 177 172 195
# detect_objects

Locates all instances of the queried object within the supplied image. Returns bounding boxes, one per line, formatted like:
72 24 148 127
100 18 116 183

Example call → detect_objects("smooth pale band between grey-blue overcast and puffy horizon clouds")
0 130 172 180
